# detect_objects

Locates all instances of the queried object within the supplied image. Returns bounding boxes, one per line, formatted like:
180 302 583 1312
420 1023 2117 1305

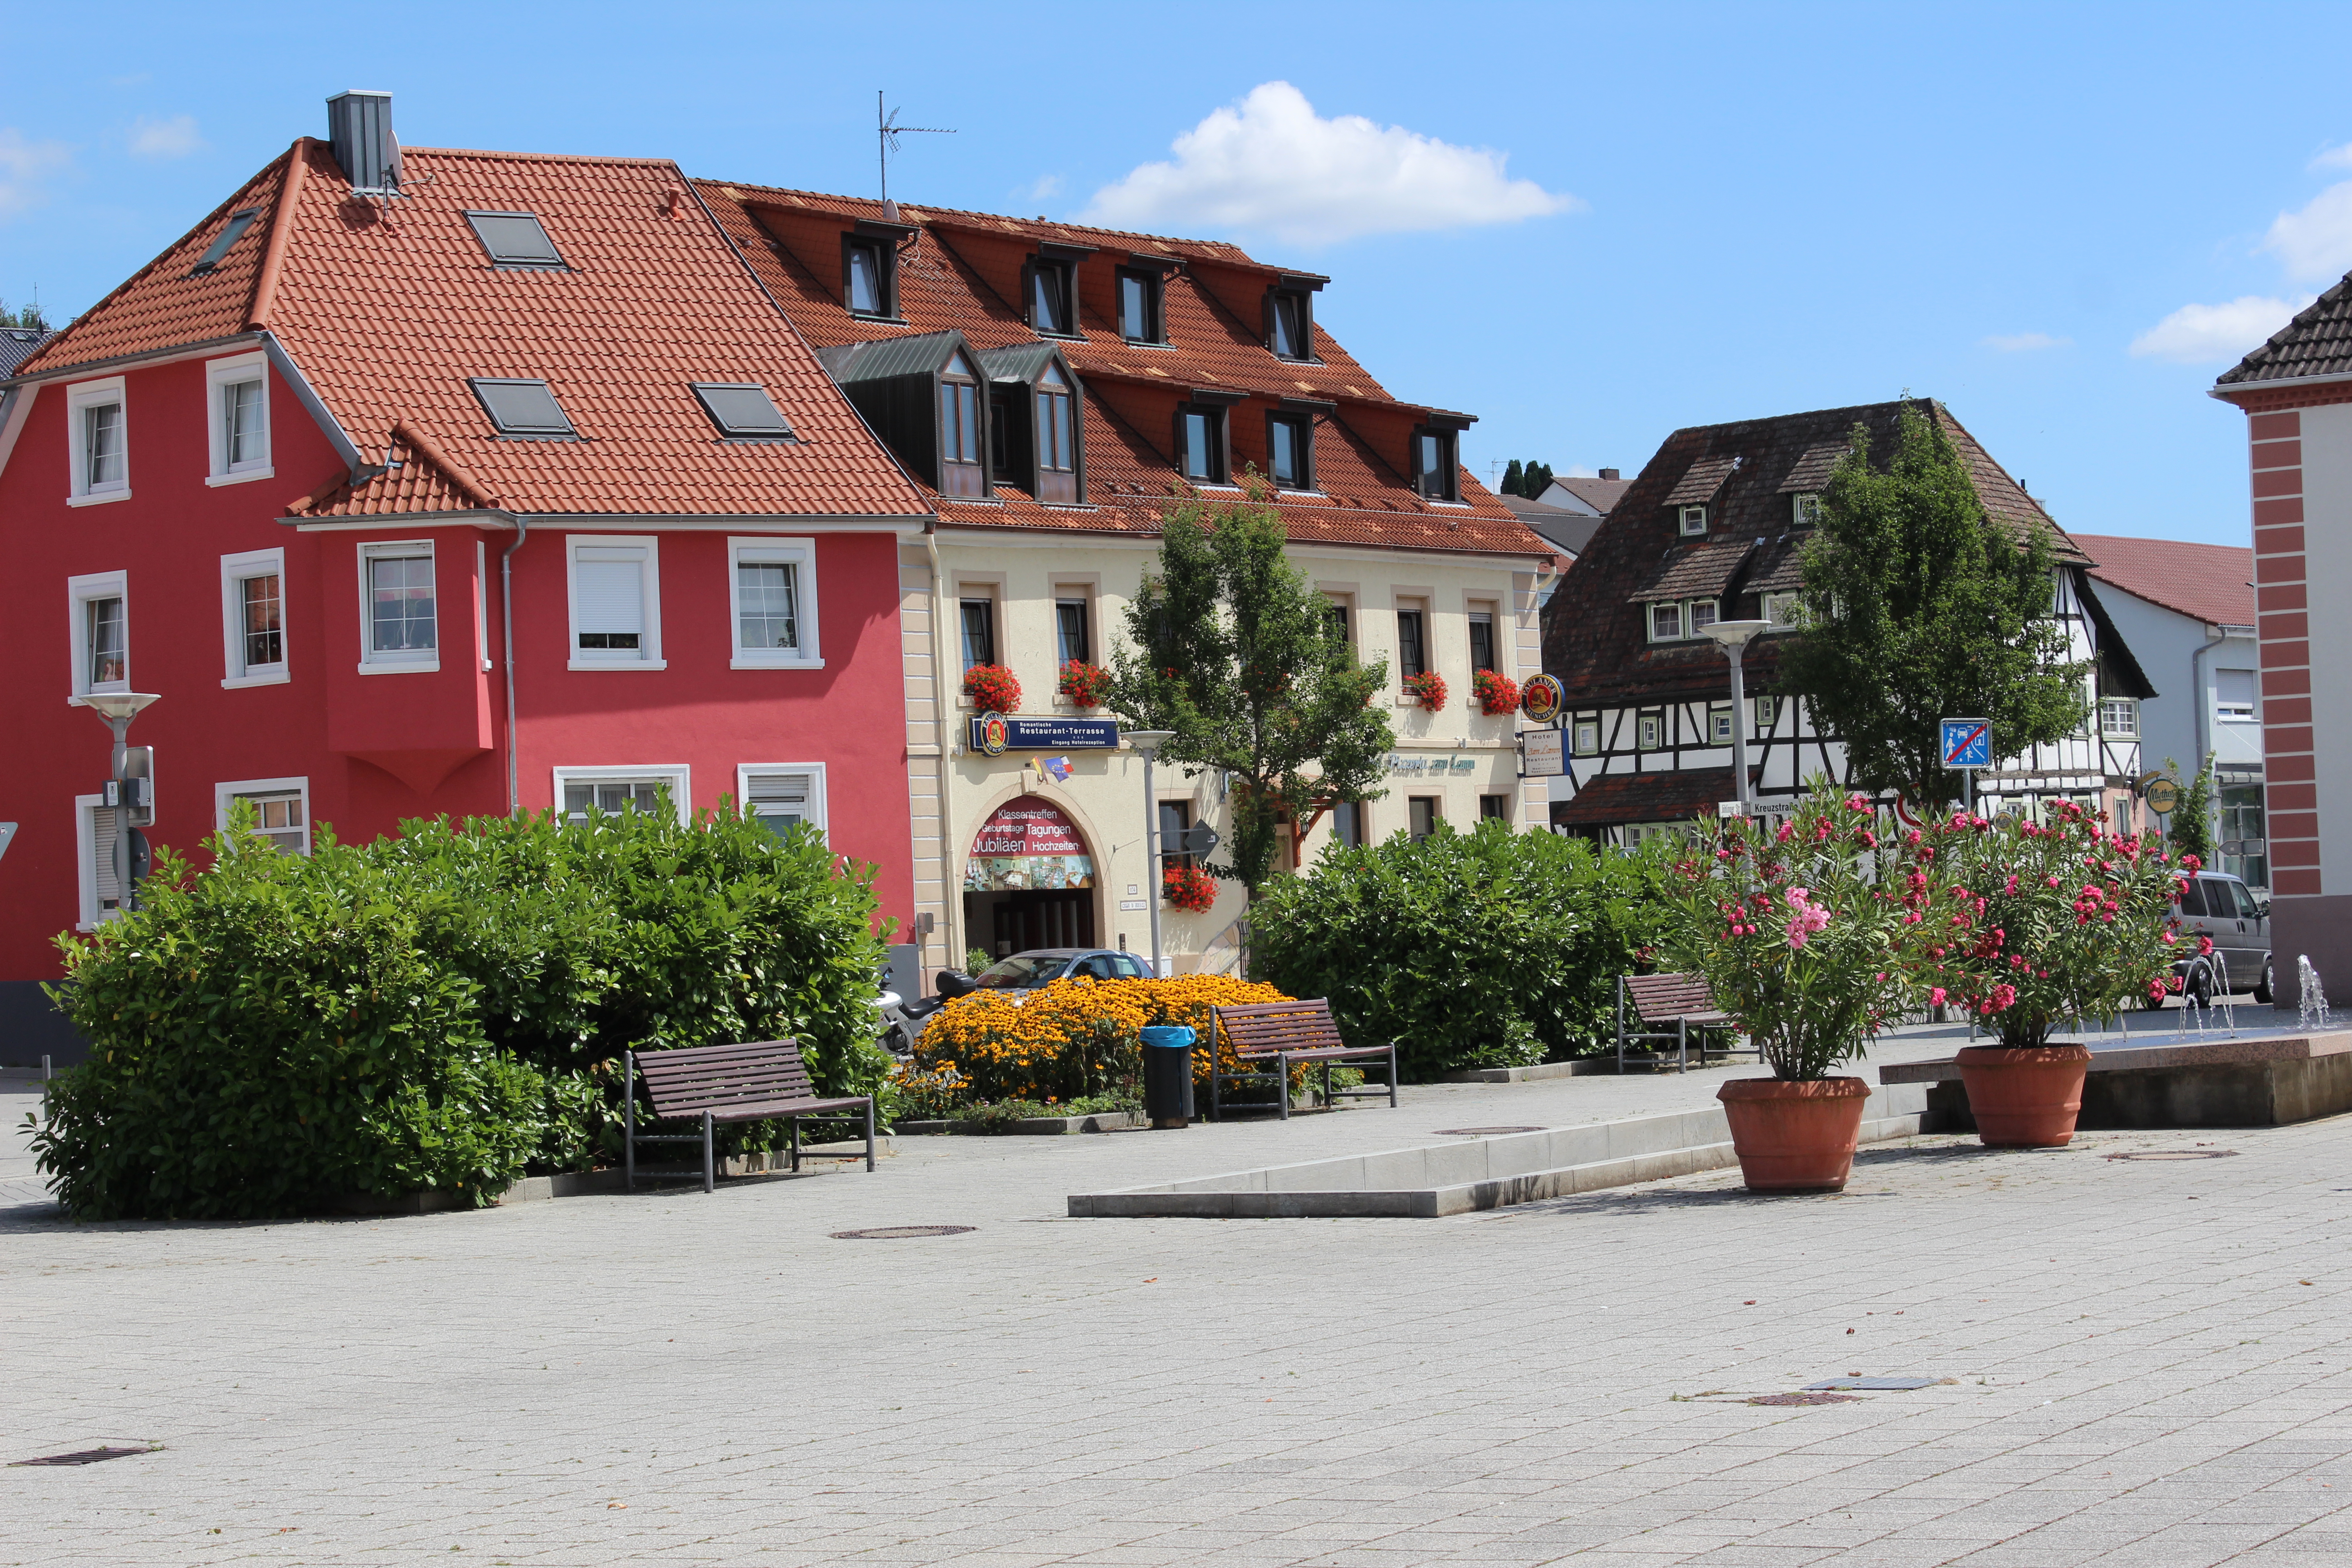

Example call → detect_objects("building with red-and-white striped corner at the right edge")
2213 277 2352 995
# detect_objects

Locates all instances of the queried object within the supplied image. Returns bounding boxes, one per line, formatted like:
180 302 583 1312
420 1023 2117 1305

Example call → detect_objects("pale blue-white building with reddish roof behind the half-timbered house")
2074 534 2270 889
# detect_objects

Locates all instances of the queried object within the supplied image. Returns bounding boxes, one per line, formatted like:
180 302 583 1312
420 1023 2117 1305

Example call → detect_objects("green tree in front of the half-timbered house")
1778 404 2091 808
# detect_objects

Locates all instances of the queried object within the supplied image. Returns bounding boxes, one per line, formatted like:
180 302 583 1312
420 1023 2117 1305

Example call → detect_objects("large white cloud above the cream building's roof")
1084 82 1583 245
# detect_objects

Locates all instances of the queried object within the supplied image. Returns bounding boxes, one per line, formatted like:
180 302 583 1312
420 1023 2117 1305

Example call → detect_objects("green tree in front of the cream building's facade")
1108 482 1395 900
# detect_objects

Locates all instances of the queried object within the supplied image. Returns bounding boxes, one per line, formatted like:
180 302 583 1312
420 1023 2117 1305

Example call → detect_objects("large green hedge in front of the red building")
33 806 889 1220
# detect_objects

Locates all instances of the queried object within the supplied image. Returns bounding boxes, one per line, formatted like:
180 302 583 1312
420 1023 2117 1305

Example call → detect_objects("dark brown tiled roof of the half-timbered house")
1543 400 2088 705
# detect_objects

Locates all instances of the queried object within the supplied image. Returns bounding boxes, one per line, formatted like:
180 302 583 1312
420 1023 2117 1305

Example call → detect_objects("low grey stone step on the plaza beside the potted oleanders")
1068 1084 1926 1220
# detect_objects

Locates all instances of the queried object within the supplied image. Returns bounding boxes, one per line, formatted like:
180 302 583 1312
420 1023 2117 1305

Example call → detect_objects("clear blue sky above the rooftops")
0 0 2352 543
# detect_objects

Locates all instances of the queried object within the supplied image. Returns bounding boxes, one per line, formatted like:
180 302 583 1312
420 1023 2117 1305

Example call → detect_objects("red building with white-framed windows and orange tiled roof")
0 94 931 1060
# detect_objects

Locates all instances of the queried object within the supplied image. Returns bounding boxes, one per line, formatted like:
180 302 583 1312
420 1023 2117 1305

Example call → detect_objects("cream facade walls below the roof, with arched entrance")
898 540 1548 975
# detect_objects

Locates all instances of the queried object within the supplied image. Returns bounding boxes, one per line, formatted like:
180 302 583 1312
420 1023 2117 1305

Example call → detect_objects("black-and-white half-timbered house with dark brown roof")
1543 400 2150 844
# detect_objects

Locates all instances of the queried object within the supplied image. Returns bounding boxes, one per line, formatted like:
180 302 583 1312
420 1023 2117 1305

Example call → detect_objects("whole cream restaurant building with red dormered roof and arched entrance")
696 181 1555 971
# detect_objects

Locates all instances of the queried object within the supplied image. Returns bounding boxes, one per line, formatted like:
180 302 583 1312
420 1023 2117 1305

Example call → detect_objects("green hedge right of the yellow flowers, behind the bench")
1249 820 1667 1079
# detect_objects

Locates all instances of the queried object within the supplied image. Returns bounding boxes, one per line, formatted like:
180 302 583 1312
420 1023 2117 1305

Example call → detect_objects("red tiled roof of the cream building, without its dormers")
696 181 1550 559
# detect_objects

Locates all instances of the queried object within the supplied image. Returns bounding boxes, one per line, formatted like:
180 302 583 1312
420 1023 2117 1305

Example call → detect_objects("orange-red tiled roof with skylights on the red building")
21 139 929 519
